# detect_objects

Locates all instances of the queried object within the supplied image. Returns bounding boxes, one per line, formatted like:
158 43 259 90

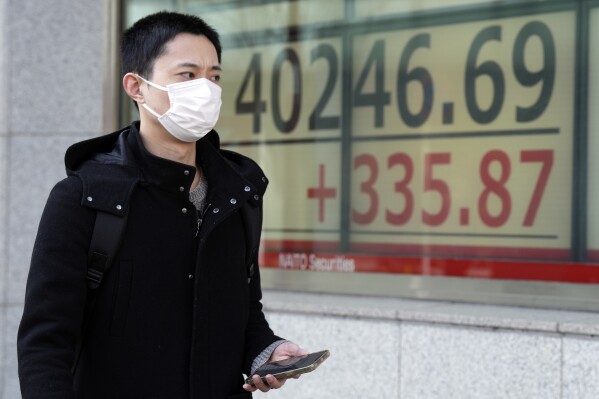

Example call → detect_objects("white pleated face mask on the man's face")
137 75 222 143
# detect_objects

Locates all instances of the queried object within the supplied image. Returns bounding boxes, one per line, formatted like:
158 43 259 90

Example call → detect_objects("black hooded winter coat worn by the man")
18 124 279 399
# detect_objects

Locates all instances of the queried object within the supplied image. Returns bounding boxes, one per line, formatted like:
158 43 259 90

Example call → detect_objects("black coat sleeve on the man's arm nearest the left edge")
17 176 95 399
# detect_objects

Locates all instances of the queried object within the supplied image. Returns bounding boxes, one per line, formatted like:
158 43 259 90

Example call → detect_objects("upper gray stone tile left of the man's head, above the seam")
6 0 104 138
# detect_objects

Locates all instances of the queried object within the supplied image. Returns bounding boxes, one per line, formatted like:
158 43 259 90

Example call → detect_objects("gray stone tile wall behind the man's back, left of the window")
0 0 106 399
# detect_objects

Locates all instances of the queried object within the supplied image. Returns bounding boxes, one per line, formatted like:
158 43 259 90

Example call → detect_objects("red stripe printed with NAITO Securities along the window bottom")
261 242 599 284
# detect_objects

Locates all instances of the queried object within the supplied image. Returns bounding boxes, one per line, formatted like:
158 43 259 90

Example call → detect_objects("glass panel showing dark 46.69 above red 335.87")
351 11 576 260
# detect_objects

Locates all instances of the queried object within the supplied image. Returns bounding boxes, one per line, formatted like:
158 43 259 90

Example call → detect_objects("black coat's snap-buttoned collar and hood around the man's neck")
65 122 268 215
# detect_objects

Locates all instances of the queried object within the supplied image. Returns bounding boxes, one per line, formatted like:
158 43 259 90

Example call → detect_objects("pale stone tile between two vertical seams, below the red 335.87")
399 323 561 399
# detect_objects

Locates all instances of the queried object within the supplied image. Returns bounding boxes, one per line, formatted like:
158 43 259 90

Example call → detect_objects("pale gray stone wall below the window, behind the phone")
254 291 599 399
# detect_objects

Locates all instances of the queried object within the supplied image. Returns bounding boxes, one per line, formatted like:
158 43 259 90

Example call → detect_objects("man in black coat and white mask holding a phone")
18 12 305 399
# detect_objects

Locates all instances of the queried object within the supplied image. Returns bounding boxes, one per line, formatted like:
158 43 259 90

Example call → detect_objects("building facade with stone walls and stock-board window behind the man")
0 0 599 399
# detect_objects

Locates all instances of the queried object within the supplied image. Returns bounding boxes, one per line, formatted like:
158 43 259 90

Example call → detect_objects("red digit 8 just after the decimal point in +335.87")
478 150 512 227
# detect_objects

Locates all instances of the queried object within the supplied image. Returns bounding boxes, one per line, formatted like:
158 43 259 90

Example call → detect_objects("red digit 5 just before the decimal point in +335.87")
422 152 451 226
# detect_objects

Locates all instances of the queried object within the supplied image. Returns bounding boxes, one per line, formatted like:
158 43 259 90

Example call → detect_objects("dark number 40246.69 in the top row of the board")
235 21 556 133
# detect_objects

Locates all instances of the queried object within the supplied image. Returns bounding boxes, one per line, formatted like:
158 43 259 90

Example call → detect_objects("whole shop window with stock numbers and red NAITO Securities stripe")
126 0 599 298
